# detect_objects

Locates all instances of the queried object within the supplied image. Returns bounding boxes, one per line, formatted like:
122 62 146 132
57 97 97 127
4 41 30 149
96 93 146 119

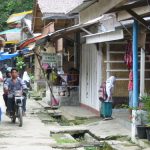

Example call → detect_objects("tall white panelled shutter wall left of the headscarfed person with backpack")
80 44 102 110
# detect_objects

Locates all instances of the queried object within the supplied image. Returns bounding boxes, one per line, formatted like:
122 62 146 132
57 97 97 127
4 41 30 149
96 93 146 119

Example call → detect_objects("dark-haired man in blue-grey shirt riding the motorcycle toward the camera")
4 68 27 116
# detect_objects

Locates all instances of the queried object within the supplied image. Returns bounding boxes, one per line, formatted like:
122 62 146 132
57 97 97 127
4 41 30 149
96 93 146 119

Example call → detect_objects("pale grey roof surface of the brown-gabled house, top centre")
38 0 84 14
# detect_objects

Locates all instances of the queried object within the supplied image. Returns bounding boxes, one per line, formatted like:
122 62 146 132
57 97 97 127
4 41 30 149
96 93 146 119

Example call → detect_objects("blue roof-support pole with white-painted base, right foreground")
132 20 138 141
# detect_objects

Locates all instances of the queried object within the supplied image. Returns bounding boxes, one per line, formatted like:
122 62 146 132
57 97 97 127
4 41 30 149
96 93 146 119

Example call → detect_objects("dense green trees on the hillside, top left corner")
0 0 33 31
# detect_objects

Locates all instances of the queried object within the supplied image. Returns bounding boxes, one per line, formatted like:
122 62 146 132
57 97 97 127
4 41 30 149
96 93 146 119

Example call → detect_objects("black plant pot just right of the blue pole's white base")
137 125 147 139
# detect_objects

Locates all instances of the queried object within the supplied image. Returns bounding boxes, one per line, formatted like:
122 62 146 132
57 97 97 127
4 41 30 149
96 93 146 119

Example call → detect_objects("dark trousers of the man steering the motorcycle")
7 97 27 112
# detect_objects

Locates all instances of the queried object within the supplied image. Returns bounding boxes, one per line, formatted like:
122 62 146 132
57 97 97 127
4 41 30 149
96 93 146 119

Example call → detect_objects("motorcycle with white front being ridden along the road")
10 91 25 127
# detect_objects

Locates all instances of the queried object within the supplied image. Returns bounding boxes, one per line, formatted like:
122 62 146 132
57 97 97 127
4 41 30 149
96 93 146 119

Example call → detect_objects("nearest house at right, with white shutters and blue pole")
63 0 150 139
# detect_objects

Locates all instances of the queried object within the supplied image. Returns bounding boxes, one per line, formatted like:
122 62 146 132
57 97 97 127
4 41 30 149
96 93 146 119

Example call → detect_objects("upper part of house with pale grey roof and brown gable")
32 0 83 33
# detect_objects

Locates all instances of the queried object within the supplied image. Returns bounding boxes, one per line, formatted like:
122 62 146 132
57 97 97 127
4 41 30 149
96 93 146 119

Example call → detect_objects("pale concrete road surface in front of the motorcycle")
0 88 55 150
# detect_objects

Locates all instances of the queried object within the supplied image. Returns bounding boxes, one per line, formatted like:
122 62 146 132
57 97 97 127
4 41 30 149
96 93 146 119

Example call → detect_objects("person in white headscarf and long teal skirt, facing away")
102 76 116 120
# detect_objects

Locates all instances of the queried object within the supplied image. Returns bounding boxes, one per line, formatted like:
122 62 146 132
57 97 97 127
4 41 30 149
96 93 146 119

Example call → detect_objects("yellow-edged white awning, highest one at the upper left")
7 11 32 24
